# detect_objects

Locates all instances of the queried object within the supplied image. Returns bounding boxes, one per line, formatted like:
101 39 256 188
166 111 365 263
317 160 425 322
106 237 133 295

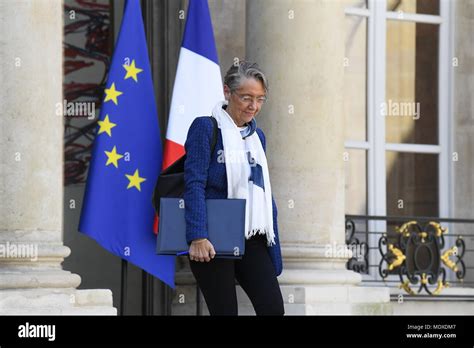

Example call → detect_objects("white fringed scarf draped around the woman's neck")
212 101 275 246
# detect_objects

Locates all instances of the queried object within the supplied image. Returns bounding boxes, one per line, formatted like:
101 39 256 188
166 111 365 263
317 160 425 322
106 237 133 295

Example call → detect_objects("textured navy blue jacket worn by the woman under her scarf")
184 116 283 275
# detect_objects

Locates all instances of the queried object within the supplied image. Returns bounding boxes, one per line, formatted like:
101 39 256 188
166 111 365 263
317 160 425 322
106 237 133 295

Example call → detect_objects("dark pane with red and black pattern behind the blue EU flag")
63 0 113 186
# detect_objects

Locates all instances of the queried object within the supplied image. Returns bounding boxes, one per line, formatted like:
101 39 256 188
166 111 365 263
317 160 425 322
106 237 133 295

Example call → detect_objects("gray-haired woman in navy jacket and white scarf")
184 61 284 315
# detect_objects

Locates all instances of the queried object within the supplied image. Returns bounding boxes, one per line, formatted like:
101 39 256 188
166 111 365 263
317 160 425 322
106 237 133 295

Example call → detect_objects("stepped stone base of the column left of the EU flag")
0 239 117 315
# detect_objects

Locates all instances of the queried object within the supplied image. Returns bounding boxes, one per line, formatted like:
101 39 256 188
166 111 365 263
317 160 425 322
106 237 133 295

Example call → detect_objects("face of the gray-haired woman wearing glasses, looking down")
224 78 265 127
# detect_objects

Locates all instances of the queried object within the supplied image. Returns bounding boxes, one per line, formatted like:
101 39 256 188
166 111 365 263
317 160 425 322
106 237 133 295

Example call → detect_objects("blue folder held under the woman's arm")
156 198 245 258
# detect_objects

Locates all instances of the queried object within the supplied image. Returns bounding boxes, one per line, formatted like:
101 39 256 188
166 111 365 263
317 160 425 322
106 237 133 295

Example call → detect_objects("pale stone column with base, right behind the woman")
246 0 390 314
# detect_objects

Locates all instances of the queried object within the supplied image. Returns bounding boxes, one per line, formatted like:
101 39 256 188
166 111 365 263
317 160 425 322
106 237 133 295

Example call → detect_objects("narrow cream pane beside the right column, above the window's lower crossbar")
344 16 367 141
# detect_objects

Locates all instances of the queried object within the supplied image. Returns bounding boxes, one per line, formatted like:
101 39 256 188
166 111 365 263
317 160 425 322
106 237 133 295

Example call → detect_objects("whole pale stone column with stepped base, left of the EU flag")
0 0 116 315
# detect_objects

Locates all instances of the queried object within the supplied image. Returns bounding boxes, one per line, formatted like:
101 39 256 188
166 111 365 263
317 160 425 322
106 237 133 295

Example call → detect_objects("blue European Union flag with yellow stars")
79 0 175 288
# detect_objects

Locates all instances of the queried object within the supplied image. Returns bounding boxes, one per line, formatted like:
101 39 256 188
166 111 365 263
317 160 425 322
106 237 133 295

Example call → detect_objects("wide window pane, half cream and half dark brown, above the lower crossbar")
381 21 439 144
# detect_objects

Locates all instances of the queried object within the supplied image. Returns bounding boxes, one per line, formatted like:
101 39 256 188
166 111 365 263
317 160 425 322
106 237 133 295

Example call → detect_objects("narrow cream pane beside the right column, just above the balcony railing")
344 149 367 215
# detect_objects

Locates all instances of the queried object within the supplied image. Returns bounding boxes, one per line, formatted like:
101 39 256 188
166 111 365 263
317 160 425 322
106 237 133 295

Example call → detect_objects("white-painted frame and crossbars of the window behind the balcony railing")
344 0 454 279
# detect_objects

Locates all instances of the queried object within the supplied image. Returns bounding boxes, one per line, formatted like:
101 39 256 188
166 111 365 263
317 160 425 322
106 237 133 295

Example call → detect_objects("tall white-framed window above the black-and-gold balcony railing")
344 0 452 275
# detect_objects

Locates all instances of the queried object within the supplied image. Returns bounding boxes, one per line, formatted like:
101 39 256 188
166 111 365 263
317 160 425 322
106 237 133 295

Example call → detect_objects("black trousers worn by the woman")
189 235 285 315
